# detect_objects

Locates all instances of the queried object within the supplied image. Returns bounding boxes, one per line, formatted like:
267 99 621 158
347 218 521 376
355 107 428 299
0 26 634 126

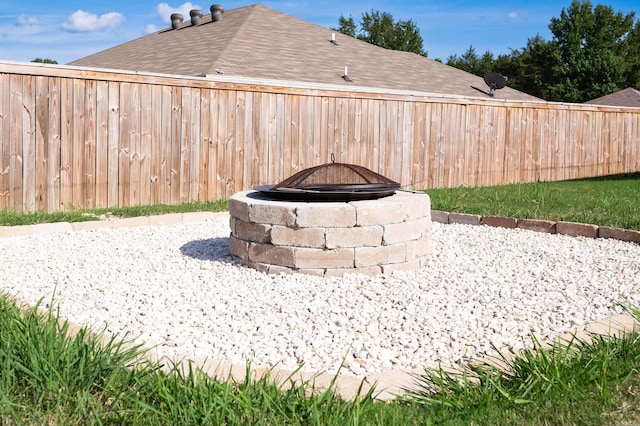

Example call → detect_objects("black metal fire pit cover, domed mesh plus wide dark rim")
254 156 400 201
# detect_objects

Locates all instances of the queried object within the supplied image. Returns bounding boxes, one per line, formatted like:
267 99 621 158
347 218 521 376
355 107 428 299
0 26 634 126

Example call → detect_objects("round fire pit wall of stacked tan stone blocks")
229 191 431 276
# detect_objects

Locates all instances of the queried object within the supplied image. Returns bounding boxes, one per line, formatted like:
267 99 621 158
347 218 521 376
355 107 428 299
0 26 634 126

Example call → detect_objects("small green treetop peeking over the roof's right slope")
334 10 427 57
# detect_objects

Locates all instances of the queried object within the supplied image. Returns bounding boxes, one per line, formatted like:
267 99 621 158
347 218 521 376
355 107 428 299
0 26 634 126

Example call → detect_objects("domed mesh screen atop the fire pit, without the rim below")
271 163 399 191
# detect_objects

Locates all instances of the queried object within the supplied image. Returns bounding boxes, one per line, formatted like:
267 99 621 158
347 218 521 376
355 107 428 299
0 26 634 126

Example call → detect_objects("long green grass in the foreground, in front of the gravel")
0 296 640 425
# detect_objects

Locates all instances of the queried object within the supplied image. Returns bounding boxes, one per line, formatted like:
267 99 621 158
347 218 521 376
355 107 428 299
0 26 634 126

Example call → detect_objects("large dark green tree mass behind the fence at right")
447 0 640 102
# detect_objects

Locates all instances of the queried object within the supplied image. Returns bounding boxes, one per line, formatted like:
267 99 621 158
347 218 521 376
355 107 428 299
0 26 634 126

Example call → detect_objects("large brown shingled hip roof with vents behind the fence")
69 4 540 101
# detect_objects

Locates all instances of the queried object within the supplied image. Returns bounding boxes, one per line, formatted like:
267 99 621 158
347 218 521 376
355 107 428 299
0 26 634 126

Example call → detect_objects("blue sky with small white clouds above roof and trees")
0 0 640 64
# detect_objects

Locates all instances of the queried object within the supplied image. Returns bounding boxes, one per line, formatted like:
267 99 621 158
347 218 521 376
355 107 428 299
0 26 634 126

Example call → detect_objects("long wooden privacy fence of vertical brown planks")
0 63 640 212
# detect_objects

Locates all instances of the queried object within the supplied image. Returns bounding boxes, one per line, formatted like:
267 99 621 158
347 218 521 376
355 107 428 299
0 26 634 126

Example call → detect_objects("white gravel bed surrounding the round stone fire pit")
0 217 640 376
